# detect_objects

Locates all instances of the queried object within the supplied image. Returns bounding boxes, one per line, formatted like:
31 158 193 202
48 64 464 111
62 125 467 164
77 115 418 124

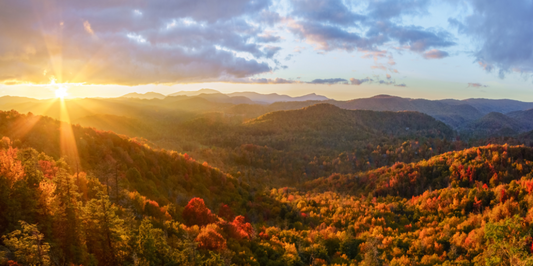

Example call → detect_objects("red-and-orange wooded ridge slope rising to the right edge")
306 145 533 197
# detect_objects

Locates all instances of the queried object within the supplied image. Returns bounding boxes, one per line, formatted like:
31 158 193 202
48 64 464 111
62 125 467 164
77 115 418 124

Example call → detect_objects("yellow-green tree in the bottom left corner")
2 221 50 266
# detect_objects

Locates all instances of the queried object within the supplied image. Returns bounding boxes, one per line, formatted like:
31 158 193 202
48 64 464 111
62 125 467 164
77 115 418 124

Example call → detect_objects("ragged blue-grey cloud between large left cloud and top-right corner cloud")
288 0 455 58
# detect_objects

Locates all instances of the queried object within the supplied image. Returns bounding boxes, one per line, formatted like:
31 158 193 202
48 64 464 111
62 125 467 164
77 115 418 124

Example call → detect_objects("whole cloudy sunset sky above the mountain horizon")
0 0 533 102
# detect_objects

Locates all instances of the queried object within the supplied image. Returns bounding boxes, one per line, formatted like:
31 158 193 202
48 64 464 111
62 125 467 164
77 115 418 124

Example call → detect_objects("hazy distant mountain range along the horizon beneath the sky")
0 89 533 136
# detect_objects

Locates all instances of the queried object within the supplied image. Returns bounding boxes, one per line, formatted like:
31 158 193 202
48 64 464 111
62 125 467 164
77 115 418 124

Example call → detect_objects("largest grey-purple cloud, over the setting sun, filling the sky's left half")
0 0 280 85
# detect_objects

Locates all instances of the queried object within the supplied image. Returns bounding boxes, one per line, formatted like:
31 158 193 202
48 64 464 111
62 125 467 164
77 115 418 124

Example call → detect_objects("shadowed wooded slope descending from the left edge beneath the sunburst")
0 111 247 208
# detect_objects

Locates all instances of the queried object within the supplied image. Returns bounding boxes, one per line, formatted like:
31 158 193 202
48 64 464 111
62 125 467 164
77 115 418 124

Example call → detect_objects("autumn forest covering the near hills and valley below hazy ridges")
0 98 533 266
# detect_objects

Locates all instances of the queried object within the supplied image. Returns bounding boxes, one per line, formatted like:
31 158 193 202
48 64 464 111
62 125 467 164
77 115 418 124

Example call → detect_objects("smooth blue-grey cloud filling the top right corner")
449 0 533 78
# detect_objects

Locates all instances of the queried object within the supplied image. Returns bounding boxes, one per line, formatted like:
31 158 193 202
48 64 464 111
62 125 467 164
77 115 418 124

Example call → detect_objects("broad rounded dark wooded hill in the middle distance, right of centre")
241 104 453 148
